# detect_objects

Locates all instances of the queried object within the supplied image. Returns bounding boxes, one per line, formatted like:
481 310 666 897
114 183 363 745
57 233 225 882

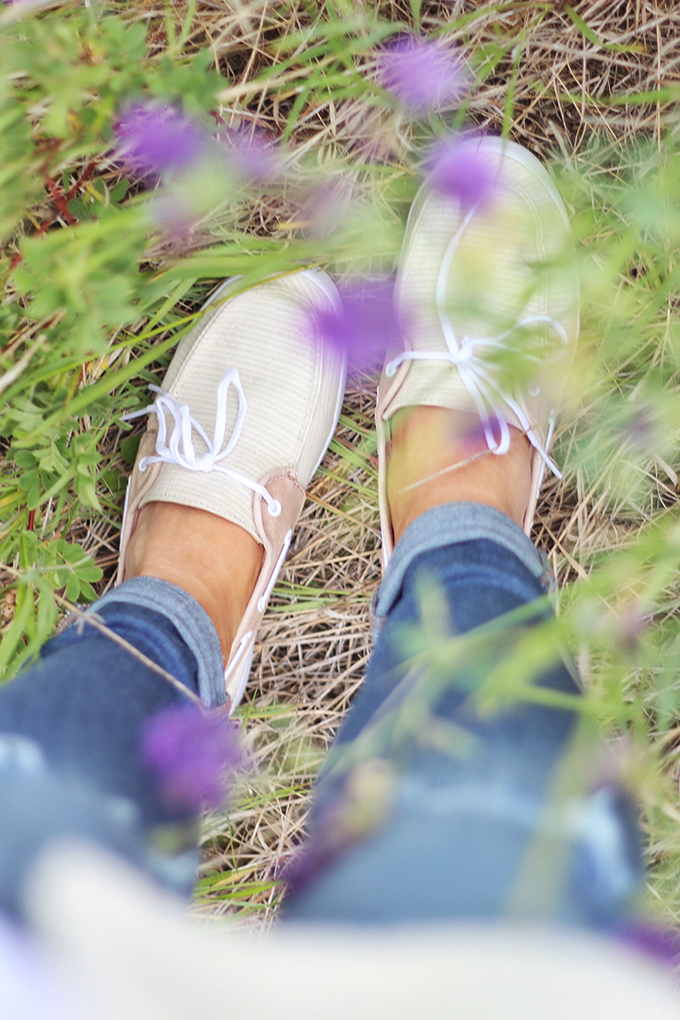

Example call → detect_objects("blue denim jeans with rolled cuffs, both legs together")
0 503 642 928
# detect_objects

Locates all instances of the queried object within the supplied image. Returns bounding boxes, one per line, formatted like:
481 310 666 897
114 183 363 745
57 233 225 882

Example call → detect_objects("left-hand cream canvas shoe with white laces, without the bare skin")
117 269 347 711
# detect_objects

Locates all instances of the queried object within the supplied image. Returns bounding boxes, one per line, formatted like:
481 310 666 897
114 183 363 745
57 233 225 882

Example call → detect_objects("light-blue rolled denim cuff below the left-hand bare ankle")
88 576 226 708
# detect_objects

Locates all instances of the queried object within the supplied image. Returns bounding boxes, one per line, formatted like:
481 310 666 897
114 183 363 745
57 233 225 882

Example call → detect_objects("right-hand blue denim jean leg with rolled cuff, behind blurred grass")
285 503 642 928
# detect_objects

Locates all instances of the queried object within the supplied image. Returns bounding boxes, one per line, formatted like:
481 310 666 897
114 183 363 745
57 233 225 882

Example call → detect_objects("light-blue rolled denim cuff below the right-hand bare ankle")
373 503 551 625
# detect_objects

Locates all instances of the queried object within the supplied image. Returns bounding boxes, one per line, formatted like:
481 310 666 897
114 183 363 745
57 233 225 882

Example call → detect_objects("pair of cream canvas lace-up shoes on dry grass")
118 138 577 710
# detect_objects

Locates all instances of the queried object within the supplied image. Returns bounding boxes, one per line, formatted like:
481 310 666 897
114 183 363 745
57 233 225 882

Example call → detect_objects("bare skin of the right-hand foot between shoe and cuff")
387 406 531 542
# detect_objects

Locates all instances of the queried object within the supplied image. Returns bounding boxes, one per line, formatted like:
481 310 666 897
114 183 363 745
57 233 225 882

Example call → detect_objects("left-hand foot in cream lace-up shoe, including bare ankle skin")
118 270 345 708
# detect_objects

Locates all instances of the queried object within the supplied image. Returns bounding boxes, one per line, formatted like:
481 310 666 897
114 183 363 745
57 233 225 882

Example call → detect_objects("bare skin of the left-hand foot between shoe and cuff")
125 502 262 662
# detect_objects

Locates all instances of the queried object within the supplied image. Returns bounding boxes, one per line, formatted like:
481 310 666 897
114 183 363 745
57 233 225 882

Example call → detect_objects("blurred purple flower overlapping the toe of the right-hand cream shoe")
427 137 496 210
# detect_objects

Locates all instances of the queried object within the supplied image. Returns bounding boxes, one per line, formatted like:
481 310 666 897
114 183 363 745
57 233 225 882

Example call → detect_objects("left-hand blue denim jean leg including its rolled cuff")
0 577 224 914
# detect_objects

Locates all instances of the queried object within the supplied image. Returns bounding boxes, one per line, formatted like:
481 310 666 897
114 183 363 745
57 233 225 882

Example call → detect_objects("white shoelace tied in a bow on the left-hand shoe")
123 368 281 517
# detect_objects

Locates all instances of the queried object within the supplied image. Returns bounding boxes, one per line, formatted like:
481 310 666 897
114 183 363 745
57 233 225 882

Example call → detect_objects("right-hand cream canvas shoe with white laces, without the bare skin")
376 137 578 566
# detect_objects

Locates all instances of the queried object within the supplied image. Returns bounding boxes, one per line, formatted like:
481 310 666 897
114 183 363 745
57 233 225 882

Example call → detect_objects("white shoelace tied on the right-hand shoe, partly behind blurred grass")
385 206 569 478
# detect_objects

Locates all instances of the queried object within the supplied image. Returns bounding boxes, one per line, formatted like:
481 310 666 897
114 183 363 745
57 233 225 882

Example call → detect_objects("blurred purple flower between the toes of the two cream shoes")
315 278 404 369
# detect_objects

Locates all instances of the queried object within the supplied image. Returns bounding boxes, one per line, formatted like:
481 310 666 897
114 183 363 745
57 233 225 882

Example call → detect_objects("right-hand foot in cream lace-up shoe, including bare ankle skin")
376 138 578 564
